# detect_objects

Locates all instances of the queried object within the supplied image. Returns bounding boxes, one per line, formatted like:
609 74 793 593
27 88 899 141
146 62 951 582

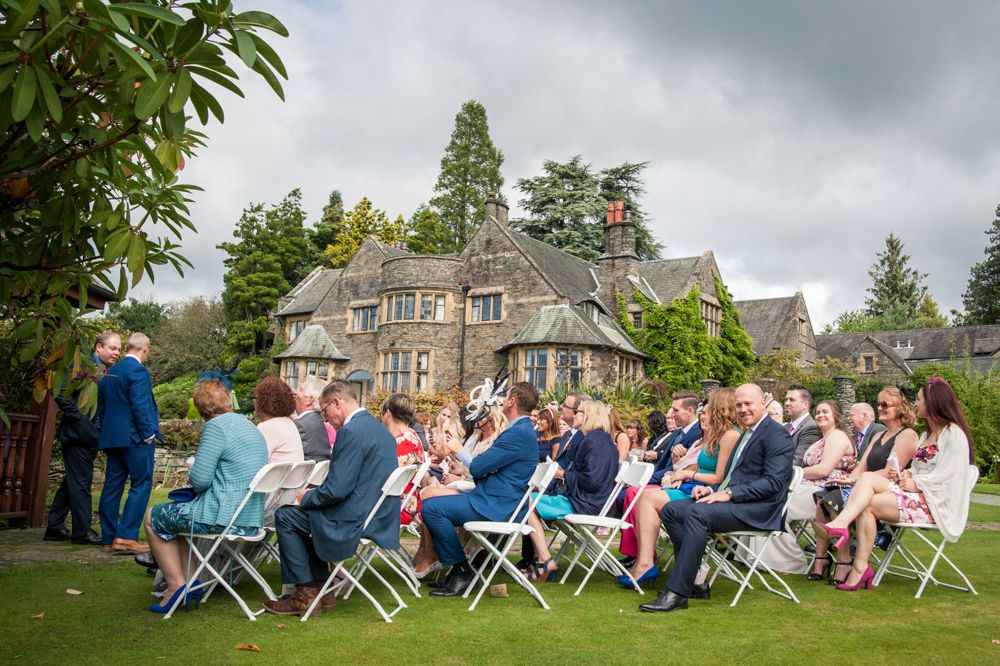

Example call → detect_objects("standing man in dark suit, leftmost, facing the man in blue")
45 331 122 546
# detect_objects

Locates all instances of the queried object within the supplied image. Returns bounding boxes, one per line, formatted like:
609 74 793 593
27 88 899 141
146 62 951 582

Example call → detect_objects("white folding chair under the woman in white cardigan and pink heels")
873 465 979 599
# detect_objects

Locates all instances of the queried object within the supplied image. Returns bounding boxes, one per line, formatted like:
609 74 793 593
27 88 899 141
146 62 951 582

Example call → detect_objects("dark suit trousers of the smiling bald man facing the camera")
660 499 751 597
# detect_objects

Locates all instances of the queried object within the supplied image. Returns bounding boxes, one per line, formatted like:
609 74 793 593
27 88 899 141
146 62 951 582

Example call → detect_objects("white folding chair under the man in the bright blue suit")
462 461 559 611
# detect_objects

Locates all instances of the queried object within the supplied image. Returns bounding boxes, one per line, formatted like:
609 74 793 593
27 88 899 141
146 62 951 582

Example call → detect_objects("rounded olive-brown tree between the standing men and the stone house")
148 296 227 382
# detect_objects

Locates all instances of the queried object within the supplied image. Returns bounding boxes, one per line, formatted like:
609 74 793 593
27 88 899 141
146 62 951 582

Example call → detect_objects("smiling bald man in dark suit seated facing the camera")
639 384 795 612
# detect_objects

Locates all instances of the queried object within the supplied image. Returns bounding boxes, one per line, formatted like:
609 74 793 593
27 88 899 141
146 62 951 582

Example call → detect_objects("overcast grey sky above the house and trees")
134 0 1000 331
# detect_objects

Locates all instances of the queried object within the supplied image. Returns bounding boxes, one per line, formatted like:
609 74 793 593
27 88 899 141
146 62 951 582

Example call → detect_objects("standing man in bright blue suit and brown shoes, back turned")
97 333 160 555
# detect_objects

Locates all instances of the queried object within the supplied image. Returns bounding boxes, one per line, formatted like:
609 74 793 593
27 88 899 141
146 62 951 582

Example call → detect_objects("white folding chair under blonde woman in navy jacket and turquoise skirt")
561 462 654 596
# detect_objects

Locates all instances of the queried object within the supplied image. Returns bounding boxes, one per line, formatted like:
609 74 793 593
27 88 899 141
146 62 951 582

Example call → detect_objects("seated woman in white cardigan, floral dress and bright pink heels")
821 376 974 592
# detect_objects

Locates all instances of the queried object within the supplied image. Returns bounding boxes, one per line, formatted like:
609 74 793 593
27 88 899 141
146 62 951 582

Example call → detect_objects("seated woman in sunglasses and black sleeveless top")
809 386 918 585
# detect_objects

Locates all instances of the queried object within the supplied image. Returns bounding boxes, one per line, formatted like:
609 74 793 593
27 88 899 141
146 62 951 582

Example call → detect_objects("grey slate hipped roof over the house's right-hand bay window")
497 304 646 358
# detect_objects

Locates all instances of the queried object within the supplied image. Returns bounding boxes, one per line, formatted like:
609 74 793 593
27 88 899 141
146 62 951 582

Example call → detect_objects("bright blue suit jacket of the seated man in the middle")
466 418 538 520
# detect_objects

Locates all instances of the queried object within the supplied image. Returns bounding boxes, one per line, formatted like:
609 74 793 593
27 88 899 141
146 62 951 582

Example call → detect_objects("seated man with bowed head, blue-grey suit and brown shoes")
264 379 399 615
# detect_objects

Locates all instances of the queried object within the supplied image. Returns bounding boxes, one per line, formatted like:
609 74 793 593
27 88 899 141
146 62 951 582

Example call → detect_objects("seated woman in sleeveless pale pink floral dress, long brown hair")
749 400 857 574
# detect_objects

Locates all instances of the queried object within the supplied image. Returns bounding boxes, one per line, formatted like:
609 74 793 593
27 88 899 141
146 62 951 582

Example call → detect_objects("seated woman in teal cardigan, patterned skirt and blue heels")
146 379 267 613
